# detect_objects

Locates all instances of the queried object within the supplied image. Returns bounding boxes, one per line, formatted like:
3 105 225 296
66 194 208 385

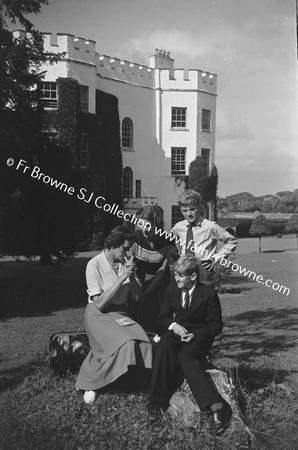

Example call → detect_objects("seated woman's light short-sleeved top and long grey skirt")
76 252 152 391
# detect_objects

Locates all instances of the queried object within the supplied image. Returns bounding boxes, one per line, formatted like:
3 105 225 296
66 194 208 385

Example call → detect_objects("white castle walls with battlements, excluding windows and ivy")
12 33 217 229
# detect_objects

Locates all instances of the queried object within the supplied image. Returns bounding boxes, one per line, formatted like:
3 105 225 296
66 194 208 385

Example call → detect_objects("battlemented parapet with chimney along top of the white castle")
14 31 217 94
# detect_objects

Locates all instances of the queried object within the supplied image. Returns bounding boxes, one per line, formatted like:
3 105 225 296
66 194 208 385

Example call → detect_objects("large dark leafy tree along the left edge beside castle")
0 0 72 262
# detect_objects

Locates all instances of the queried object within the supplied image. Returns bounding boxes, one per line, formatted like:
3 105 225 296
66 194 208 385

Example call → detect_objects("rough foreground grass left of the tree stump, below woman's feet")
0 361 212 450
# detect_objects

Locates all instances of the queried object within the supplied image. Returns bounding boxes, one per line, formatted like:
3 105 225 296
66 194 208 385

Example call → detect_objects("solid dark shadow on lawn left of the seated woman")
0 257 90 320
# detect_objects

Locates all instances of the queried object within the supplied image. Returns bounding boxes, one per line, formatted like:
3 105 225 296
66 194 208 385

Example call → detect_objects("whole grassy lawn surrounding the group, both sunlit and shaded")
0 237 298 450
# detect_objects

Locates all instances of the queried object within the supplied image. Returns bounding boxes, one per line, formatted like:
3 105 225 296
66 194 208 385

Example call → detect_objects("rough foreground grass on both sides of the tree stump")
0 358 298 450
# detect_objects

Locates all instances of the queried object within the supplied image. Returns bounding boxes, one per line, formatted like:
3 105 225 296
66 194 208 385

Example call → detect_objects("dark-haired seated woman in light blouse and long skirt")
76 226 152 403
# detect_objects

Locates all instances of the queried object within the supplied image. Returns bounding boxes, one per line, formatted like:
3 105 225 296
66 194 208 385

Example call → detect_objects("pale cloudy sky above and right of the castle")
22 0 298 196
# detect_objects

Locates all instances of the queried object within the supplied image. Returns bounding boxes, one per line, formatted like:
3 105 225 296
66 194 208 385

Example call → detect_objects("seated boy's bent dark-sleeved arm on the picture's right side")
189 289 223 343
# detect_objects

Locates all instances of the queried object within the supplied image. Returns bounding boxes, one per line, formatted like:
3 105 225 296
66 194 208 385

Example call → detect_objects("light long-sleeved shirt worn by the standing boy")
171 218 237 259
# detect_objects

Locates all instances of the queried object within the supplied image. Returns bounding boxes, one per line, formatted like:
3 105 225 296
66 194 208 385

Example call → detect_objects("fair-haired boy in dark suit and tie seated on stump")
148 255 232 435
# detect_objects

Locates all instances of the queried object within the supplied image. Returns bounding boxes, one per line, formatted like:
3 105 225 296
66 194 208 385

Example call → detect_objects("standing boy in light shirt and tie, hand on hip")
171 190 237 281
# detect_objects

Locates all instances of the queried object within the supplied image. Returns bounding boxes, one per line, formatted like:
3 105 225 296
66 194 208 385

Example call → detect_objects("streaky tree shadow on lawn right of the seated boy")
216 308 298 363
